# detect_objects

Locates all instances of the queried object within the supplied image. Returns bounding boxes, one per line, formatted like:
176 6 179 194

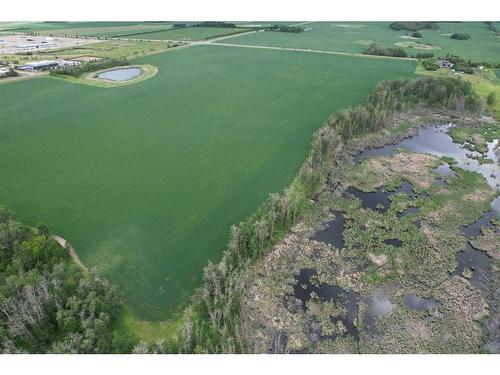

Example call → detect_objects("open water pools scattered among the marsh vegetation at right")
310 124 500 345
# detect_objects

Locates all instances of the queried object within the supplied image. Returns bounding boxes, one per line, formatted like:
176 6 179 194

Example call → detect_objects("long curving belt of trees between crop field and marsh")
180 78 484 353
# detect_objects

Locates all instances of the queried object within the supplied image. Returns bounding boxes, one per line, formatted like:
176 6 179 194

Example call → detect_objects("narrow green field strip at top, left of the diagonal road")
124 27 248 41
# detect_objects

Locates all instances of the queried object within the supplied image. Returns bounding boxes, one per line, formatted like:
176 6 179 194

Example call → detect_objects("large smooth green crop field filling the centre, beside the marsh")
0 46 415 320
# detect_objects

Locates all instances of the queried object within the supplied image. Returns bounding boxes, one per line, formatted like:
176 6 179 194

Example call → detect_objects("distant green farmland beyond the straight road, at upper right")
223 22 500 62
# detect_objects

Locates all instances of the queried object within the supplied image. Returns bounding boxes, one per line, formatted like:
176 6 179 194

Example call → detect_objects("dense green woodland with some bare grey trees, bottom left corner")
0 209 134 353
